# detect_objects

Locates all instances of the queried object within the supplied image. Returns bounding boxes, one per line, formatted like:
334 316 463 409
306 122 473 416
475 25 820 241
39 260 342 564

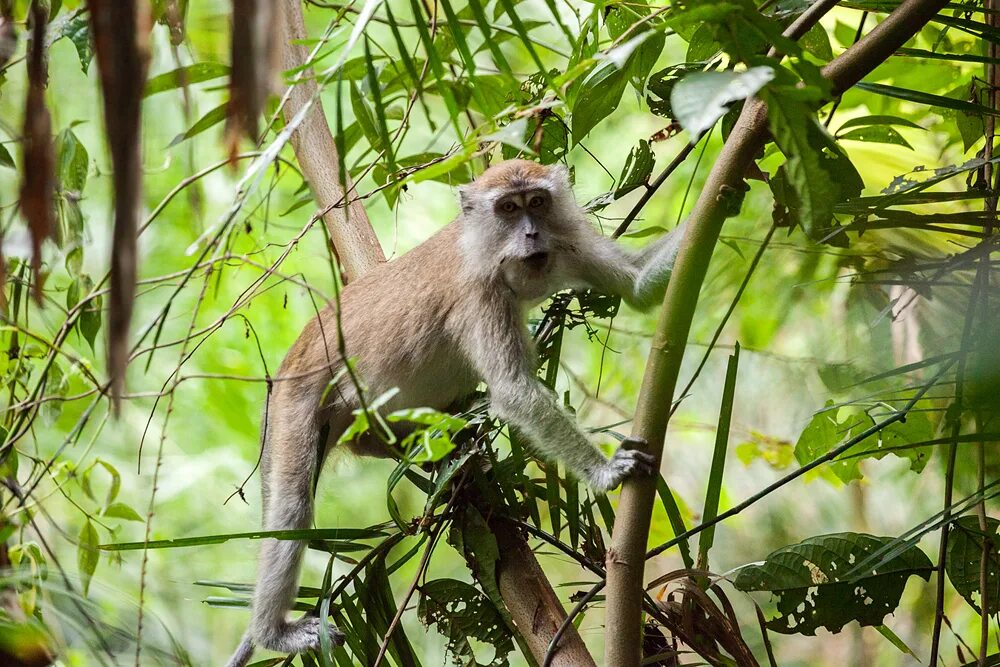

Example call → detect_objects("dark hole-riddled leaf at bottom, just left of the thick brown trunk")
417 579 514 667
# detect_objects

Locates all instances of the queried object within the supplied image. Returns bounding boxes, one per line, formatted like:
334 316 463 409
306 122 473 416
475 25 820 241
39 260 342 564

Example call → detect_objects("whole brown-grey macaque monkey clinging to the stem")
229 160 681 667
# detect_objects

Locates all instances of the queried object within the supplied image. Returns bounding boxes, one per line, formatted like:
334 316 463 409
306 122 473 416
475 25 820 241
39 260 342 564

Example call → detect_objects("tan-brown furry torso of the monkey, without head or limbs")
280 221 478 410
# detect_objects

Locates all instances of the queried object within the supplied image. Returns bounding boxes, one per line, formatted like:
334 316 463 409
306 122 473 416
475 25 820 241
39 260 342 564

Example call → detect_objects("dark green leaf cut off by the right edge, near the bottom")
945 516 1000 615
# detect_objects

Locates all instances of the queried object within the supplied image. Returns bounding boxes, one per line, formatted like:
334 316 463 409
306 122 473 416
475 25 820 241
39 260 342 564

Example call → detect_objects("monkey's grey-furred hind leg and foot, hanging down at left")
250 402 344 653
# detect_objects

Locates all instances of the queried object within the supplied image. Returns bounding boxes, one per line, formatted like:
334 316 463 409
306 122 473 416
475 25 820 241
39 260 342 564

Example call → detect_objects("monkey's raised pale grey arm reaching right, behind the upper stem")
574 223 686 310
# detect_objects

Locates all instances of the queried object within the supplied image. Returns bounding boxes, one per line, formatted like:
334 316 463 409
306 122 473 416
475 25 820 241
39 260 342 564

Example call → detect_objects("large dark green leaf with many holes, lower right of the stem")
733 533 934 635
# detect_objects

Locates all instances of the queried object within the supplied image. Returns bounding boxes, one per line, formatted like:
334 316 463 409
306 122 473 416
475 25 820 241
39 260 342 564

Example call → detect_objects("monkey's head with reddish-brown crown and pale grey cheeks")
459 160 581 298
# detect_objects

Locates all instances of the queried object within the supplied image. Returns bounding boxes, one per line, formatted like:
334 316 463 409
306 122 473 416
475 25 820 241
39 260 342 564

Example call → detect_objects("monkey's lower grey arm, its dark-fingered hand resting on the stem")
466 294 655 491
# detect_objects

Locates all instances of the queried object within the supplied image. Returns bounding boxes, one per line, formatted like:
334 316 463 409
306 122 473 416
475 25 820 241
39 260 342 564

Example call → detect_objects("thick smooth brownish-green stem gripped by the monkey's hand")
604 0 947 667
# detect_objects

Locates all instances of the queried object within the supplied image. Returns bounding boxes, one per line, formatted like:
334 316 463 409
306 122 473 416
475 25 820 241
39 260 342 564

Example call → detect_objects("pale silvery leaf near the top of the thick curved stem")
670 66 774 140
